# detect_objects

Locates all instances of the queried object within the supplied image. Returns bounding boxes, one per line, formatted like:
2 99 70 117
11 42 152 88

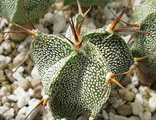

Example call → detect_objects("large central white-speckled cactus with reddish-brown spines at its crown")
26 0 134 120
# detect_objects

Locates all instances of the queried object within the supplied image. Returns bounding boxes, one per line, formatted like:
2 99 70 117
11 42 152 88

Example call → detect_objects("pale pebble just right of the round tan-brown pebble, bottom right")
131 102 143 115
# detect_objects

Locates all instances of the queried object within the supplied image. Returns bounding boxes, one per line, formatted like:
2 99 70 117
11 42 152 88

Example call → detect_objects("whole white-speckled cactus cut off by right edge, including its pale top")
131 0 156 84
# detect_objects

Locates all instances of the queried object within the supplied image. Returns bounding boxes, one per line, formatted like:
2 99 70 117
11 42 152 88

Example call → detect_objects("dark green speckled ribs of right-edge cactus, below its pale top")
131 12 156 75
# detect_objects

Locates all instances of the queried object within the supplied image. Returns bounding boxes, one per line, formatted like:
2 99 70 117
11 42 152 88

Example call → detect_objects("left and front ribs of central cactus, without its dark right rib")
29 13 111 120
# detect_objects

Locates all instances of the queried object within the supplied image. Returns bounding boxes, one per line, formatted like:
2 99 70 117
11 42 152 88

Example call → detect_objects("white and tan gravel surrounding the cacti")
0 0 156 120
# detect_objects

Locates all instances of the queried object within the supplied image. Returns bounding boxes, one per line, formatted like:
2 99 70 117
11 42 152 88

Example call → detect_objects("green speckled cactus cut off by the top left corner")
0 0 55 25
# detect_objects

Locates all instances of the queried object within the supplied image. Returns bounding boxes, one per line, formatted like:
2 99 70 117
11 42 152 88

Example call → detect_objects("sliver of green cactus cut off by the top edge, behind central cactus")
63 0 114 7
